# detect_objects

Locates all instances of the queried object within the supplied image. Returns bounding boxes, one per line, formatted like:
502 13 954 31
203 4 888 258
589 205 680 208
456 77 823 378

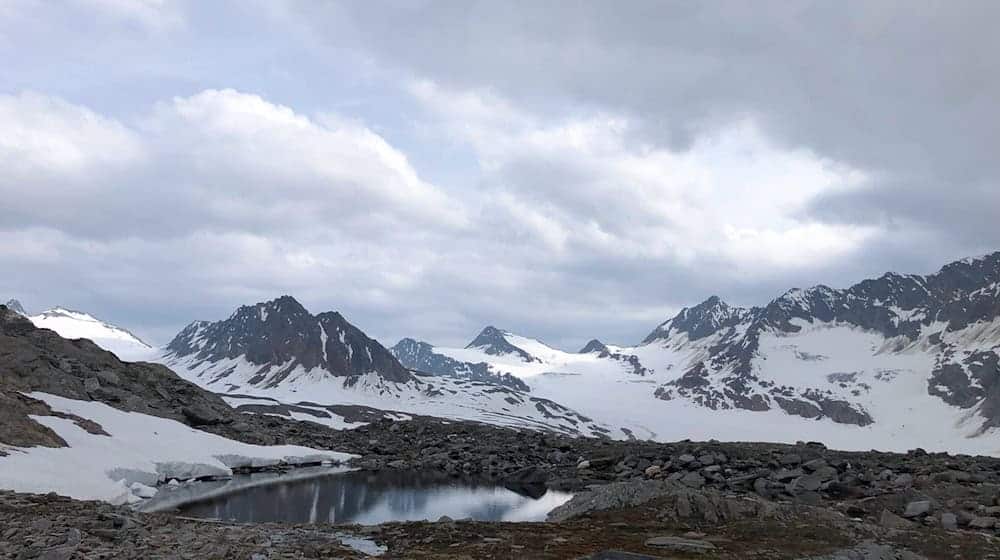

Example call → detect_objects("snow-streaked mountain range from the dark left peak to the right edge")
12 253 1000 453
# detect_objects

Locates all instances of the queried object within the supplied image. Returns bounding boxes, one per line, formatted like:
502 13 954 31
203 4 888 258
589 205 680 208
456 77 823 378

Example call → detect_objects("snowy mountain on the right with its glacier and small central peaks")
386 253 1000 454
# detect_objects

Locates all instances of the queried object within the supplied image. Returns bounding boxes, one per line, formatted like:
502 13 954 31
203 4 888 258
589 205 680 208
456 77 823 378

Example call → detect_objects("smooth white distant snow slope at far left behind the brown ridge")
27 307 154 361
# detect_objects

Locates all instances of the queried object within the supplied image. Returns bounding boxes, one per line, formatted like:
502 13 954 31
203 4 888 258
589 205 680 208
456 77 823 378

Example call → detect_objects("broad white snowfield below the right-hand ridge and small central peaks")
404 320 1000 456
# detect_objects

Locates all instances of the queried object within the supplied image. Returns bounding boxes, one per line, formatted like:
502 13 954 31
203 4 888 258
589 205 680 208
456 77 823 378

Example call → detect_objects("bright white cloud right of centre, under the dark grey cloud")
410 81 877 273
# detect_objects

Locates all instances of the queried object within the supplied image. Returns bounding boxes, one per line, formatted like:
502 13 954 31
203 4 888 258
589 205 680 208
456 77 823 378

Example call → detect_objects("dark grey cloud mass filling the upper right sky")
304 1 1000 267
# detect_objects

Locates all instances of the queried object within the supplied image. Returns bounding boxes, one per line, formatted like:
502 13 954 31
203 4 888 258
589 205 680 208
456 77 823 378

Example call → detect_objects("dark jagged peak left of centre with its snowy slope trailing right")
158 296 612 437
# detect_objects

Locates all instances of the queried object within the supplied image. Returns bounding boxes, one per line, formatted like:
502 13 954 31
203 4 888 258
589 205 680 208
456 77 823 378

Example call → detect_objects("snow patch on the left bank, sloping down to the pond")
0 393 351 504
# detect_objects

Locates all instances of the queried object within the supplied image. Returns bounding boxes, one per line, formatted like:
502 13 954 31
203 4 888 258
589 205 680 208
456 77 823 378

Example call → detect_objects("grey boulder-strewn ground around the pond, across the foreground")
0 418 1000 560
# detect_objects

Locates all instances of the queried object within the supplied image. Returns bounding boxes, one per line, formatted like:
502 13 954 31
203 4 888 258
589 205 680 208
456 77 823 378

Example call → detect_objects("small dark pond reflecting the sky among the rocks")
151 471 571 525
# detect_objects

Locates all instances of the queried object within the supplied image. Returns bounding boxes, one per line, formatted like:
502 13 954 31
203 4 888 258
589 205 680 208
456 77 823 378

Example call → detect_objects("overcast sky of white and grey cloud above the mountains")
0 0 1000 349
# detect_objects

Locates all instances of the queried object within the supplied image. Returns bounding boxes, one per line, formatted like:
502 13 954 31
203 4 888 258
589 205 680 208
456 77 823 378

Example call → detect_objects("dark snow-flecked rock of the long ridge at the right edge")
645 252 1000 429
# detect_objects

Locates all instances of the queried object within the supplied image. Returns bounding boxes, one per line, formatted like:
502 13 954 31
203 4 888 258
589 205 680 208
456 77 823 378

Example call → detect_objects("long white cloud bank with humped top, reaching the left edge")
0 90 465 238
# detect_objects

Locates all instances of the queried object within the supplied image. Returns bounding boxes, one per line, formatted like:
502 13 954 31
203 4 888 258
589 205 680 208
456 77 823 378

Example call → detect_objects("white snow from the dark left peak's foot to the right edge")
154 316 1000 456
